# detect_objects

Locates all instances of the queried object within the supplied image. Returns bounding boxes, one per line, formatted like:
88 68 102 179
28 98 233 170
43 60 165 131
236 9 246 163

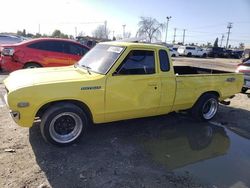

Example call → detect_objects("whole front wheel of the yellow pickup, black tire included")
40 103 88 146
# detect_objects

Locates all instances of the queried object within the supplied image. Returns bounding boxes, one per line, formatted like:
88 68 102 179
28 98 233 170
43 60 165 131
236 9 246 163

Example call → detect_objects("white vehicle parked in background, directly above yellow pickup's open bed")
177 46 207 57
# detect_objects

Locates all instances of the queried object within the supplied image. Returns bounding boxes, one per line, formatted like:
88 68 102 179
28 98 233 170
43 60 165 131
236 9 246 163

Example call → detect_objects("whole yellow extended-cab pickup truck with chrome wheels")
4 42 243 145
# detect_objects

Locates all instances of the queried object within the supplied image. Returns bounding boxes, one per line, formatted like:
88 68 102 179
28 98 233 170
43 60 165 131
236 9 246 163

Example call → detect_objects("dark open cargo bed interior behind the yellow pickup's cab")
174 66 232 75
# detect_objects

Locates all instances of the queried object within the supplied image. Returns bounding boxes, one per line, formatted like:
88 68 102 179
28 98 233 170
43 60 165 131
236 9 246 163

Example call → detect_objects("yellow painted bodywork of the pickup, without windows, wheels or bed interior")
4 42 243 127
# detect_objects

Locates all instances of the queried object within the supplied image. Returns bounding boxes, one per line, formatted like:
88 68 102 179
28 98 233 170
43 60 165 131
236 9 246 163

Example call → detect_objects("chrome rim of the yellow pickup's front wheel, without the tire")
49 112 83 144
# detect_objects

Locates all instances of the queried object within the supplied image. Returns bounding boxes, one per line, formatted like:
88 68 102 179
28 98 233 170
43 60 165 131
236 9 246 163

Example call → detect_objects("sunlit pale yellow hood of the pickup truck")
4 66 102 91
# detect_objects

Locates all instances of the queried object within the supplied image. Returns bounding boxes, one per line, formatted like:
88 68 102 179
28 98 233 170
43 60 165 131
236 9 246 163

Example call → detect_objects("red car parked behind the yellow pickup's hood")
0 38 89 72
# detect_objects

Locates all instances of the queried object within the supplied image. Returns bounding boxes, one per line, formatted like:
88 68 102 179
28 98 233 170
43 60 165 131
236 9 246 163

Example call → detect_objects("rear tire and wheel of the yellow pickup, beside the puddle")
191 93 219 121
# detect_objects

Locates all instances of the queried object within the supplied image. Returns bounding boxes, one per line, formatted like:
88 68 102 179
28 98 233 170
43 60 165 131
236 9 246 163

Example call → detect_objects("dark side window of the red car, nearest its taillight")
28 41 64 53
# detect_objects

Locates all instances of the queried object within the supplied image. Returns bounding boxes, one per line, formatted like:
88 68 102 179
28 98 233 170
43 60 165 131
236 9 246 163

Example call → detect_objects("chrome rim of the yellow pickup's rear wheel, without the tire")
202 98 218 120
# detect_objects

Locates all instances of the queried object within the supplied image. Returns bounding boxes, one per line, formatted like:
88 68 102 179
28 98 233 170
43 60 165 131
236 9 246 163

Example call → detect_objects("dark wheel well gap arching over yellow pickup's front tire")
36 100 93 122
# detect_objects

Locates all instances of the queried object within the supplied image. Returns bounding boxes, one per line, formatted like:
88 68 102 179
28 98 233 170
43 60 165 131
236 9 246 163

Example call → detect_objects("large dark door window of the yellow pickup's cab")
116 50 155 75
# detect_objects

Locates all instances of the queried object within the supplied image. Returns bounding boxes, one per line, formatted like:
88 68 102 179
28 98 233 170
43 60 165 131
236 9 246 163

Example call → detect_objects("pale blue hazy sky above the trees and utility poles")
0 0 250 46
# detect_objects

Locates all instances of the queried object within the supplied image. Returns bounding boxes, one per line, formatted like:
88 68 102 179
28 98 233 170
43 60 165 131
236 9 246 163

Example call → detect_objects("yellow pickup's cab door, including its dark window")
105 50 161 121
